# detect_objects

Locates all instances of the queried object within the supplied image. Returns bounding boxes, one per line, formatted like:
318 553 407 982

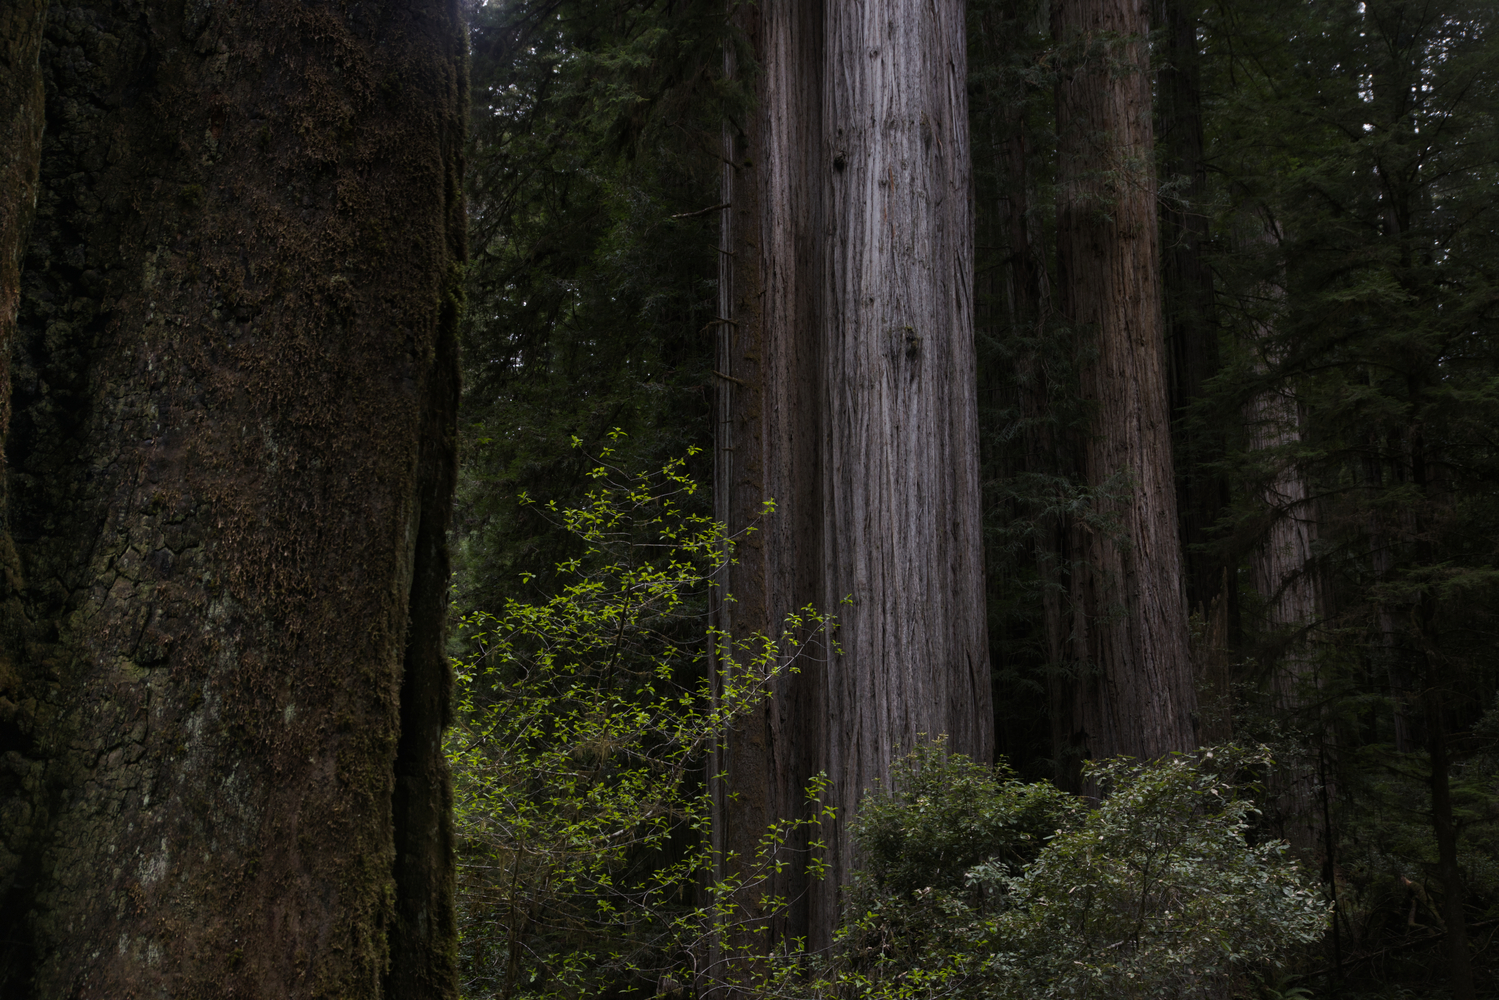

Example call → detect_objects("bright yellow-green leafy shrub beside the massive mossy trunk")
447 450 830 999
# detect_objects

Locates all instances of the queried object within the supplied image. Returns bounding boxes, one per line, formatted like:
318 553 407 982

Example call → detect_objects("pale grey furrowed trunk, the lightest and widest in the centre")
820 0 994 879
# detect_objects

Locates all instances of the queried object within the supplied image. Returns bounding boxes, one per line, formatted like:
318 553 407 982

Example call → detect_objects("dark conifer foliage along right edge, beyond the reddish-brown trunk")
1207 1 1499 997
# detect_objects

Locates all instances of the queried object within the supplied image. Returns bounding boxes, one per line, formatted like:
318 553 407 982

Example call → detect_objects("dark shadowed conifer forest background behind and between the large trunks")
454 0 1499 997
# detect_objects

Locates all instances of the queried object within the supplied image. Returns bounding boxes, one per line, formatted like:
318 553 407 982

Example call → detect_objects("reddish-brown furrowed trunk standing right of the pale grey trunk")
1052 0 1196 759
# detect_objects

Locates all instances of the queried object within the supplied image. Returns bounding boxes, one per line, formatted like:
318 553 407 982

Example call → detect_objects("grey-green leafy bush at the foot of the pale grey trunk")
764 747 1328 1000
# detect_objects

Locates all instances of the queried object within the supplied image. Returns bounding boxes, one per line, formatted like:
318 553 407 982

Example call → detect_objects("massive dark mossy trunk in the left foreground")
0 0 466 999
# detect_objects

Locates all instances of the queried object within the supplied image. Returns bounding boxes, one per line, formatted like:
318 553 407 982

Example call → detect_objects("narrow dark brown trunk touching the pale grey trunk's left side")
711 1 829 971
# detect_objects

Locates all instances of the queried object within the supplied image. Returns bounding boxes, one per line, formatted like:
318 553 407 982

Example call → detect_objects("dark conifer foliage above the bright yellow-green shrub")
456 0 733 607
